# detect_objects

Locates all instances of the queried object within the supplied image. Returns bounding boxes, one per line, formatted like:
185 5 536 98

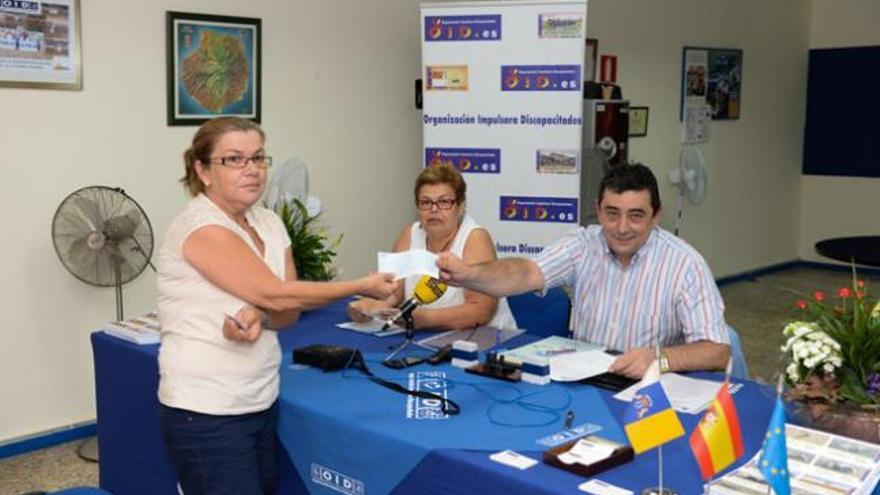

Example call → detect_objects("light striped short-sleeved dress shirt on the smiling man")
535 225 729 351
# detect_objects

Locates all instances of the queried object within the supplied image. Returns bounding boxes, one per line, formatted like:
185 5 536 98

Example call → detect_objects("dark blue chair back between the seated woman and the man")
507 287 571 337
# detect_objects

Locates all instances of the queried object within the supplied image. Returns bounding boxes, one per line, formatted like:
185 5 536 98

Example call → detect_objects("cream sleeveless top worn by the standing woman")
158 194 290 414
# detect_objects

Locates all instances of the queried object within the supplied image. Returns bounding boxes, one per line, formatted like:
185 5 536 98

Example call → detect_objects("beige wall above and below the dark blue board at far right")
800 0 880 263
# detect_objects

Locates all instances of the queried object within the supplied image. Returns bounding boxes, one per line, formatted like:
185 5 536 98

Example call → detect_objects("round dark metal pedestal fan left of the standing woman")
52 186 156 321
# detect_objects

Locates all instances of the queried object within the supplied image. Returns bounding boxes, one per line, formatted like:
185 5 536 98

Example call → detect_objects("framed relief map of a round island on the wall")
165 12 262 125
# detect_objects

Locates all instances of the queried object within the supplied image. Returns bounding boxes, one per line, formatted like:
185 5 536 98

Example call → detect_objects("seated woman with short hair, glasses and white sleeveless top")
348 165 516 330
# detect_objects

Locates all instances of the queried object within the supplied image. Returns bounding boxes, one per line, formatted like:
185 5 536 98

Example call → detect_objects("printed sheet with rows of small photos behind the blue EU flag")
710 424 880 495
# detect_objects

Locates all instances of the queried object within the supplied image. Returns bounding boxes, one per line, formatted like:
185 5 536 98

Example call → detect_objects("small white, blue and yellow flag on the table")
623 361 684 454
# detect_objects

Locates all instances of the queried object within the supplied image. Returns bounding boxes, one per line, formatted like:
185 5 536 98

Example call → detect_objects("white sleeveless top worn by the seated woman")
404 214 516 329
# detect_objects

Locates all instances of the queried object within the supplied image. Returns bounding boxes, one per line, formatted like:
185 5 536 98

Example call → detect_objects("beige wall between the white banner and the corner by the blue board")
588 0 809 277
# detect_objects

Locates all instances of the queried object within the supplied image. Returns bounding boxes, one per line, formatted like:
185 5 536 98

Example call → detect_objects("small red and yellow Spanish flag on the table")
690 380 743 480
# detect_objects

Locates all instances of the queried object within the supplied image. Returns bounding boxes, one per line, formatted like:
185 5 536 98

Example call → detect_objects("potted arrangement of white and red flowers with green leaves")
782 269 880 413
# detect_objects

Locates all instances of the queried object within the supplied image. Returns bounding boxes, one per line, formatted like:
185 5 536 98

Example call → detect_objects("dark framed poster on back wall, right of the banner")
680 46 743 120
